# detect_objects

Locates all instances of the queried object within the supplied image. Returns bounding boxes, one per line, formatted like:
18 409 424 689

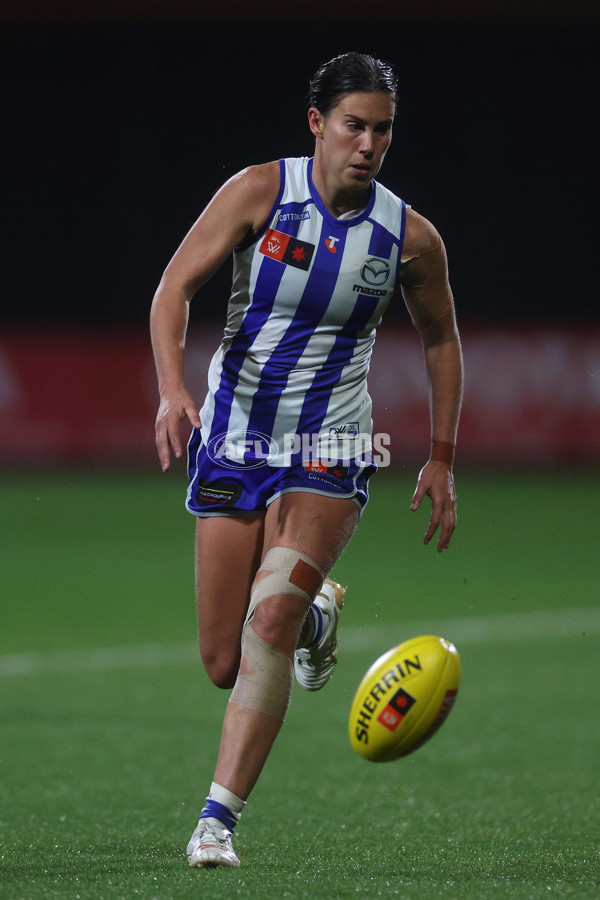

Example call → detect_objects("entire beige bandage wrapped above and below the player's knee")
229 547 323 722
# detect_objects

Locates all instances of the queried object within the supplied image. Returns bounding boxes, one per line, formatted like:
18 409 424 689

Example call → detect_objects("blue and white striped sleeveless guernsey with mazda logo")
200 157 406 466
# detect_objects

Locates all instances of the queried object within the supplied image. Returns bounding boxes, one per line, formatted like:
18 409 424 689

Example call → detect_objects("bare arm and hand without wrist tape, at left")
150 162 280 471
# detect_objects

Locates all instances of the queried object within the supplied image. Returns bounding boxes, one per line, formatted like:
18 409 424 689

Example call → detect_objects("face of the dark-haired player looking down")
309 93 396 190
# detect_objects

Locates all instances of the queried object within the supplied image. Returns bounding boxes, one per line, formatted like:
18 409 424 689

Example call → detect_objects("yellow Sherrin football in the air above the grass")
348 635 460 762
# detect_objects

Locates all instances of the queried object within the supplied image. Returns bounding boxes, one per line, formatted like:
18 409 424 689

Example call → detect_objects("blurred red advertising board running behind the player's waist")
0 325 600 466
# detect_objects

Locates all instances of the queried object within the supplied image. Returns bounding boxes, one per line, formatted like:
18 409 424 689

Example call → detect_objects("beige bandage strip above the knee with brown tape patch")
246 547 325 624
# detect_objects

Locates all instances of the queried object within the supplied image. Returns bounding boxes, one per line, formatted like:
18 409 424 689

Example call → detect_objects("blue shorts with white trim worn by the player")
185 429 377 516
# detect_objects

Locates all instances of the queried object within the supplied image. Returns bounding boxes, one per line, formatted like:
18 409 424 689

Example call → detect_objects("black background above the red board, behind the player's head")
0 0 600 329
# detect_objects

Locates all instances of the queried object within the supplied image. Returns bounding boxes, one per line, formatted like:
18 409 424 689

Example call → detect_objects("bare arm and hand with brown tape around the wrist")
400 210 463 553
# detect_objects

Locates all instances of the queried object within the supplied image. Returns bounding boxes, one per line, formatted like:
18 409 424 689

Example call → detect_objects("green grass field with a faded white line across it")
0 470 600 900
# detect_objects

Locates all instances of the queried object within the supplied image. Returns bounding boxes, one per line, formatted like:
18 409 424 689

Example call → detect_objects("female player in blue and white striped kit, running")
151 53 462 867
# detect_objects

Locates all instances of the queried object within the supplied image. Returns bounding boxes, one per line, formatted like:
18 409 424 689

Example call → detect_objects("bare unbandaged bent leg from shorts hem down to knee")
196 515 265 688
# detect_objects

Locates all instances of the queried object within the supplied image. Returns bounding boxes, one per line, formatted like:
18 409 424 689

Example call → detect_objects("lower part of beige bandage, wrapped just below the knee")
229 625 293 722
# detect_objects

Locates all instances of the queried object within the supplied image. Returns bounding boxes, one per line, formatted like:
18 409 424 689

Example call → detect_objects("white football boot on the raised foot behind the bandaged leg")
294 578 346 691
